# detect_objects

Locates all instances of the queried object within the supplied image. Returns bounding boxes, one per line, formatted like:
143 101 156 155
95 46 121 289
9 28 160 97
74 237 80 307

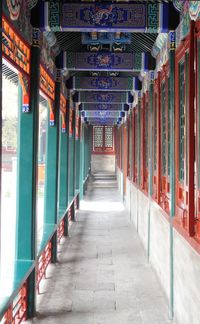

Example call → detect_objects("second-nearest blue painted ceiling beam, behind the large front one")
62 51 156 72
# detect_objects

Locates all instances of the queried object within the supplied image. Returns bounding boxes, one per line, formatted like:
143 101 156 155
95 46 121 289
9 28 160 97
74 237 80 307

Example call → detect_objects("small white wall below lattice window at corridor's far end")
91 154 115 173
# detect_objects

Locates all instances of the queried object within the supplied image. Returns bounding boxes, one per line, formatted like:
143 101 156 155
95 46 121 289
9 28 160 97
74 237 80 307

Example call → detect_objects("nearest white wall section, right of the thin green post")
174 231 200 324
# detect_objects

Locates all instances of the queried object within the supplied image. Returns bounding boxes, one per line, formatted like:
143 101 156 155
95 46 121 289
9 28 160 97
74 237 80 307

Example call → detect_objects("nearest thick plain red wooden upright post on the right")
188 21 195 236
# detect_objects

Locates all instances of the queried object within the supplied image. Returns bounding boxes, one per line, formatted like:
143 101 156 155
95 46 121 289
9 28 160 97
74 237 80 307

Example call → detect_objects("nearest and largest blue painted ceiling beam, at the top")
39 1 170 33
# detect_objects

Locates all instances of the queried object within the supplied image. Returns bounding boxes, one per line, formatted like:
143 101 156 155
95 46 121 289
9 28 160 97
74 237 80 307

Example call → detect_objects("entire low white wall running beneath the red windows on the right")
118 177 200 324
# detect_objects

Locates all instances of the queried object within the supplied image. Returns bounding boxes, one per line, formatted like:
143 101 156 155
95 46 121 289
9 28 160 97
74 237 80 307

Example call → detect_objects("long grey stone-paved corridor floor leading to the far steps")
28 177 172 324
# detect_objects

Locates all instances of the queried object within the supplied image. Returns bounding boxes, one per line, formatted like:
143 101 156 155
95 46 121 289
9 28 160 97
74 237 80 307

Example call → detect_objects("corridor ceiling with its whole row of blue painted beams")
32 0 179 125
